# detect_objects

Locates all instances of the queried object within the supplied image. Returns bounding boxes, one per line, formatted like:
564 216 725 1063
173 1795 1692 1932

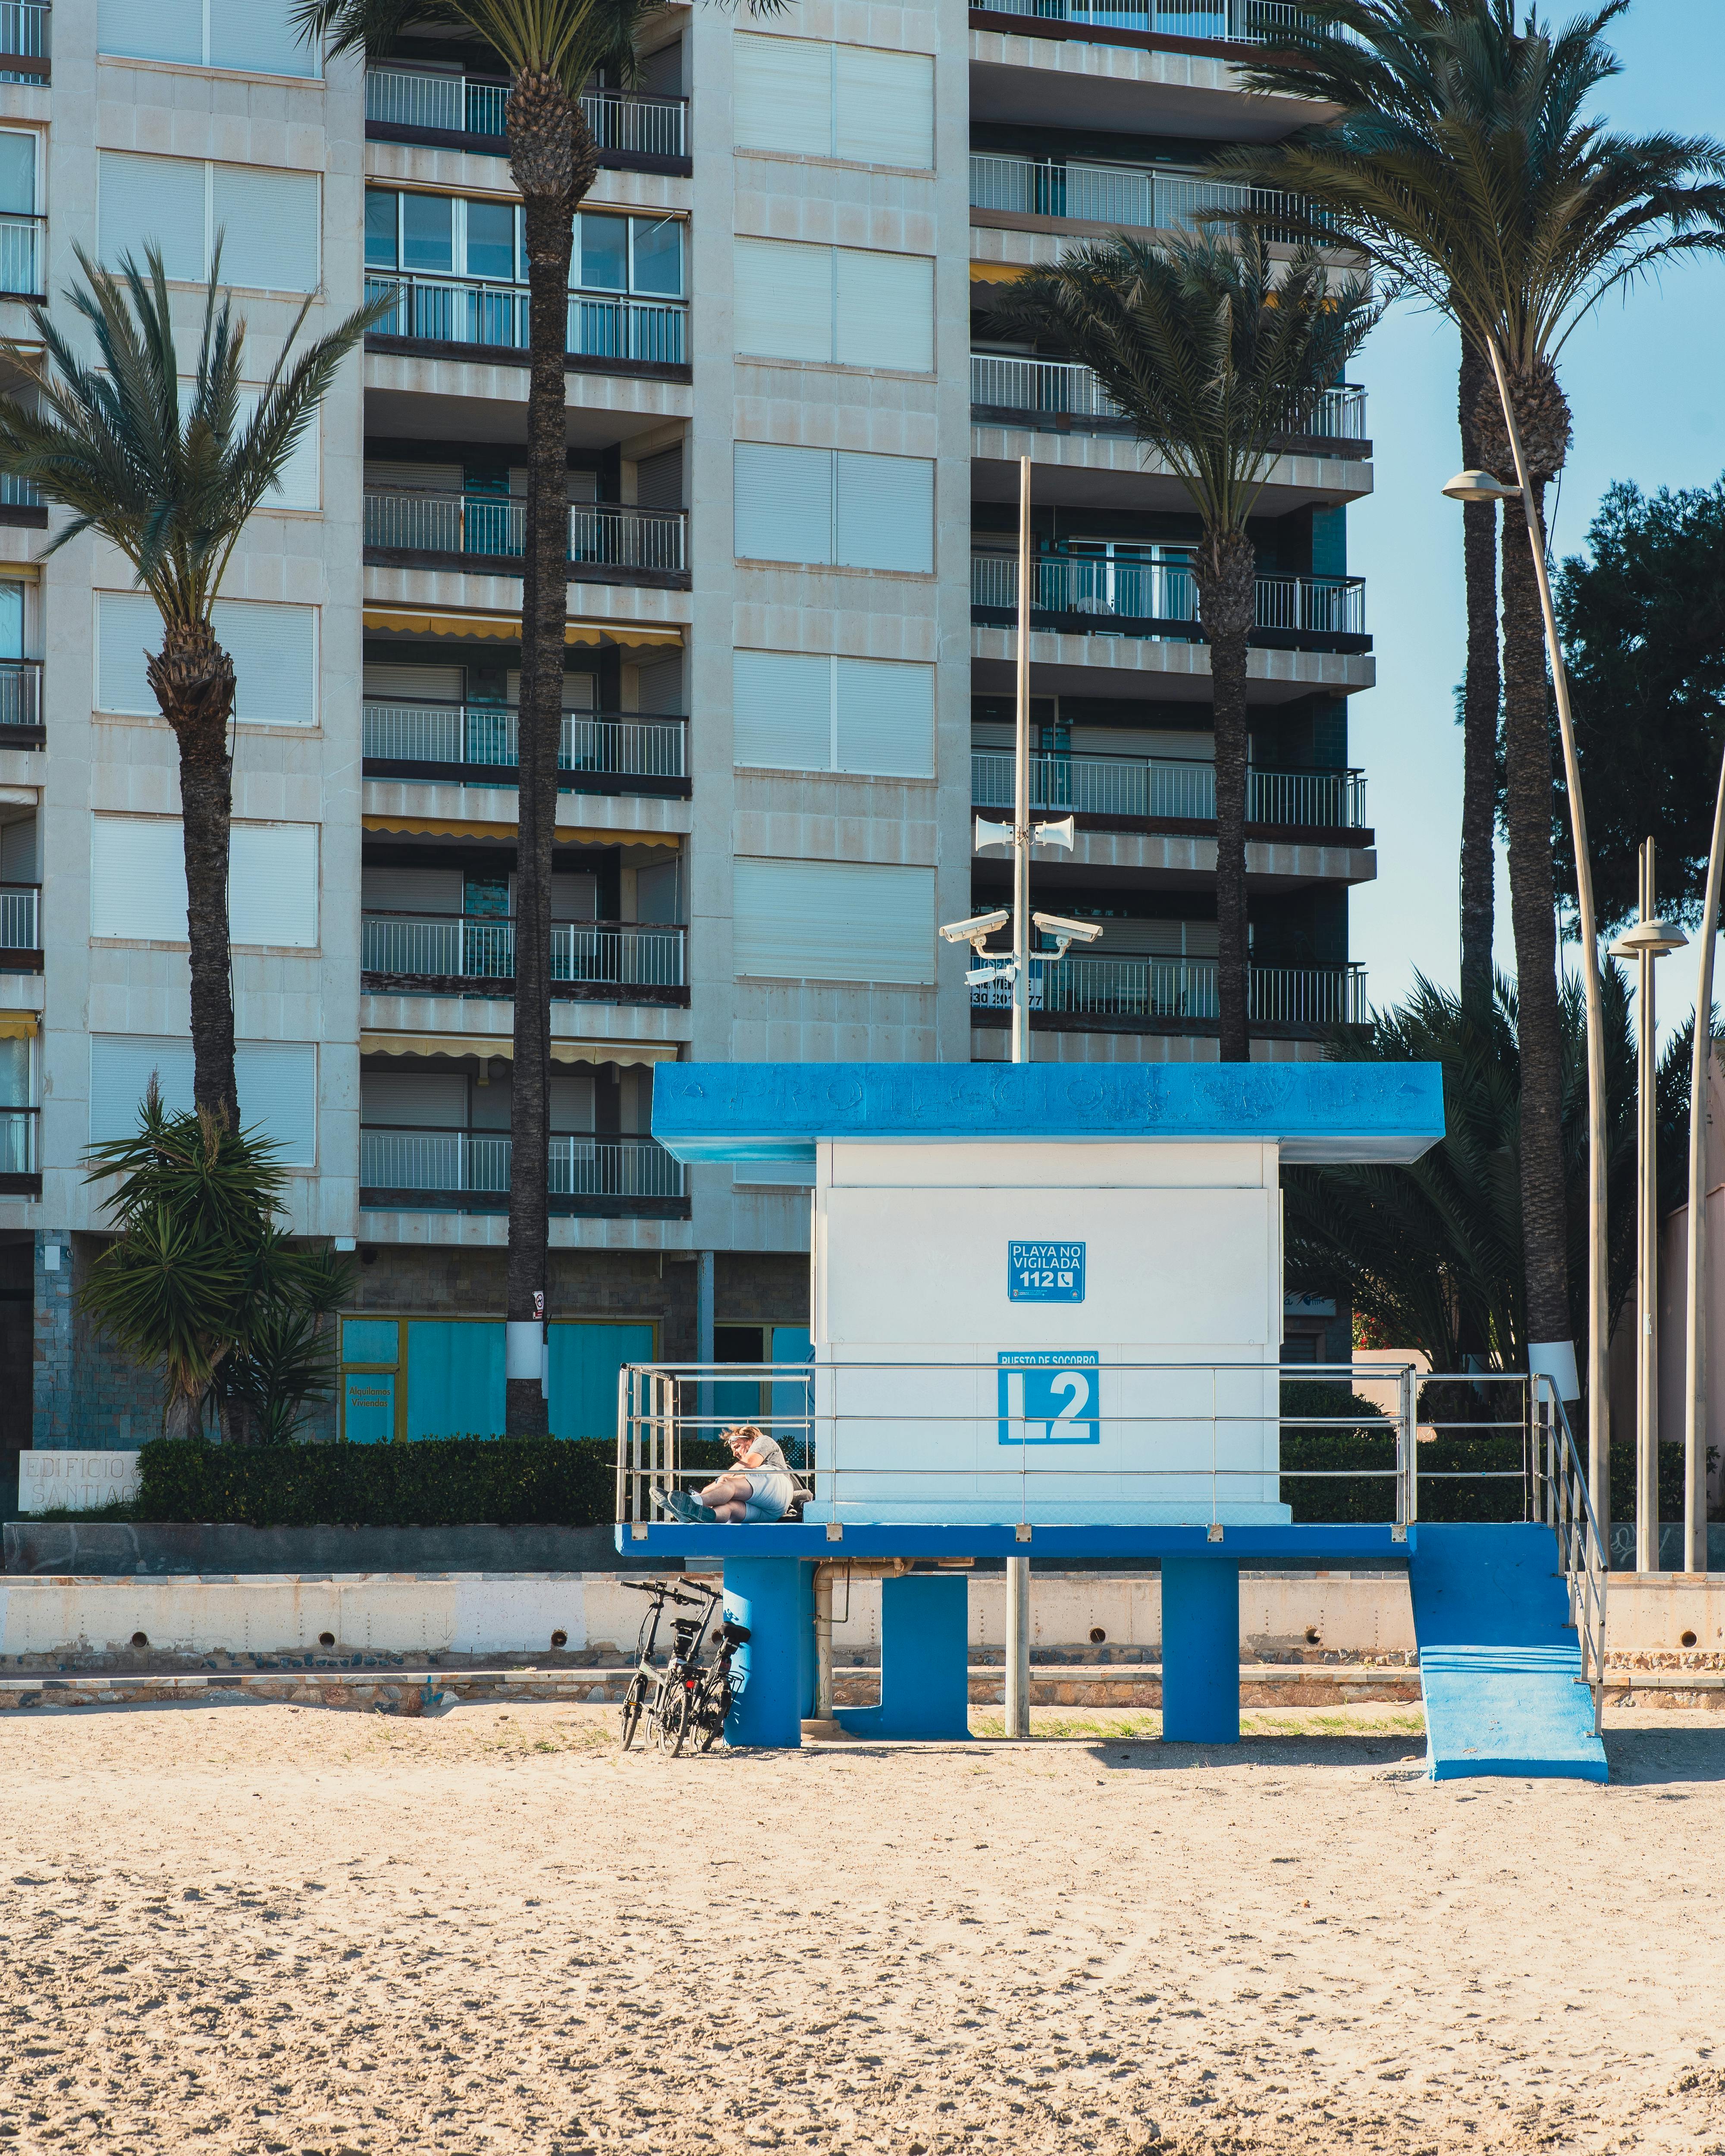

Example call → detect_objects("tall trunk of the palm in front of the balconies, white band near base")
505 75 599 1436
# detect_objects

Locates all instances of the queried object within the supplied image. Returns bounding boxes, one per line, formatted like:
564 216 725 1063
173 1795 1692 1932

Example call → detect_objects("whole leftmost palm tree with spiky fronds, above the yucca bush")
0 246 375 1130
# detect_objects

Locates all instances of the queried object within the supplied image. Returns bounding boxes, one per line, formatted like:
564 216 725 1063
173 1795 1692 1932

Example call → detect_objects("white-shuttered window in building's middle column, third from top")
733 442 934 576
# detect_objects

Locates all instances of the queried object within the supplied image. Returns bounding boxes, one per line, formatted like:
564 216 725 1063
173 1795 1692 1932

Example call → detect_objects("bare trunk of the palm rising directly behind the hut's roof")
1192 533 1257 1063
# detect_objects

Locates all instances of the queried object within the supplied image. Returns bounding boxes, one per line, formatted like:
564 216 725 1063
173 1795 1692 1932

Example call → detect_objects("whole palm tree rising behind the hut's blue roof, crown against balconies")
996 224 1378 1063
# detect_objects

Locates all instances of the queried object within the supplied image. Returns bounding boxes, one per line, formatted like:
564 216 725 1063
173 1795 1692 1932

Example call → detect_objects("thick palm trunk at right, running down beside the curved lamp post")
1503 481 1572 1341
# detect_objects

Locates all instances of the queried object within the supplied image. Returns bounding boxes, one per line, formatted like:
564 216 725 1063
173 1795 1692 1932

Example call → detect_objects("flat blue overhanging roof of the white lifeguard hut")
653 1063 1445 1162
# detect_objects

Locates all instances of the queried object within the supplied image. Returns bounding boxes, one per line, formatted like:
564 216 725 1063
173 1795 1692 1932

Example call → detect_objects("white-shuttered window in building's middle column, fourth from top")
731 651 934 778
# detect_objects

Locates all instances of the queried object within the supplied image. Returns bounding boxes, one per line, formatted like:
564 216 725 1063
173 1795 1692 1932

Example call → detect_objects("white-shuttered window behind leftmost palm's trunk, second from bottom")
91 815 317 951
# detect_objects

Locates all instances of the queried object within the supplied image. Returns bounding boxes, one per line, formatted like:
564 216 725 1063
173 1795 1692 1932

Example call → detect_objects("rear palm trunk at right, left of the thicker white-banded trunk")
1458 338 1503 1020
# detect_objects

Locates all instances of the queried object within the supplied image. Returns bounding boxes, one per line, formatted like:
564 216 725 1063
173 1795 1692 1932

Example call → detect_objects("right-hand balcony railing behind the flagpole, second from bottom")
970 748 1365 830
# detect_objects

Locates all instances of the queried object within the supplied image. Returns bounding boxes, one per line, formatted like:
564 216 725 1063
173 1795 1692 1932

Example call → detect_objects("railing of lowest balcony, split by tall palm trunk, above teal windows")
360 1123 688 1220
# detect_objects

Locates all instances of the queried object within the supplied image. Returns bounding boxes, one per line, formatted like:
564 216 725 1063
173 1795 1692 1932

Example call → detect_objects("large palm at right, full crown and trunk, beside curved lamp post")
1231 0 1725 1371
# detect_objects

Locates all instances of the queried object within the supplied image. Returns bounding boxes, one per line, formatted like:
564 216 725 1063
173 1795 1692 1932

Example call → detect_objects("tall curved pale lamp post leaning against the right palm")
1486 336 1611 1548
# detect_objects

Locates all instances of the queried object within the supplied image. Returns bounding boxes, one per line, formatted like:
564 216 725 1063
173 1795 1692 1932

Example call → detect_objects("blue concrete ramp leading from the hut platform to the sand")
1408 1522 1606 1781
